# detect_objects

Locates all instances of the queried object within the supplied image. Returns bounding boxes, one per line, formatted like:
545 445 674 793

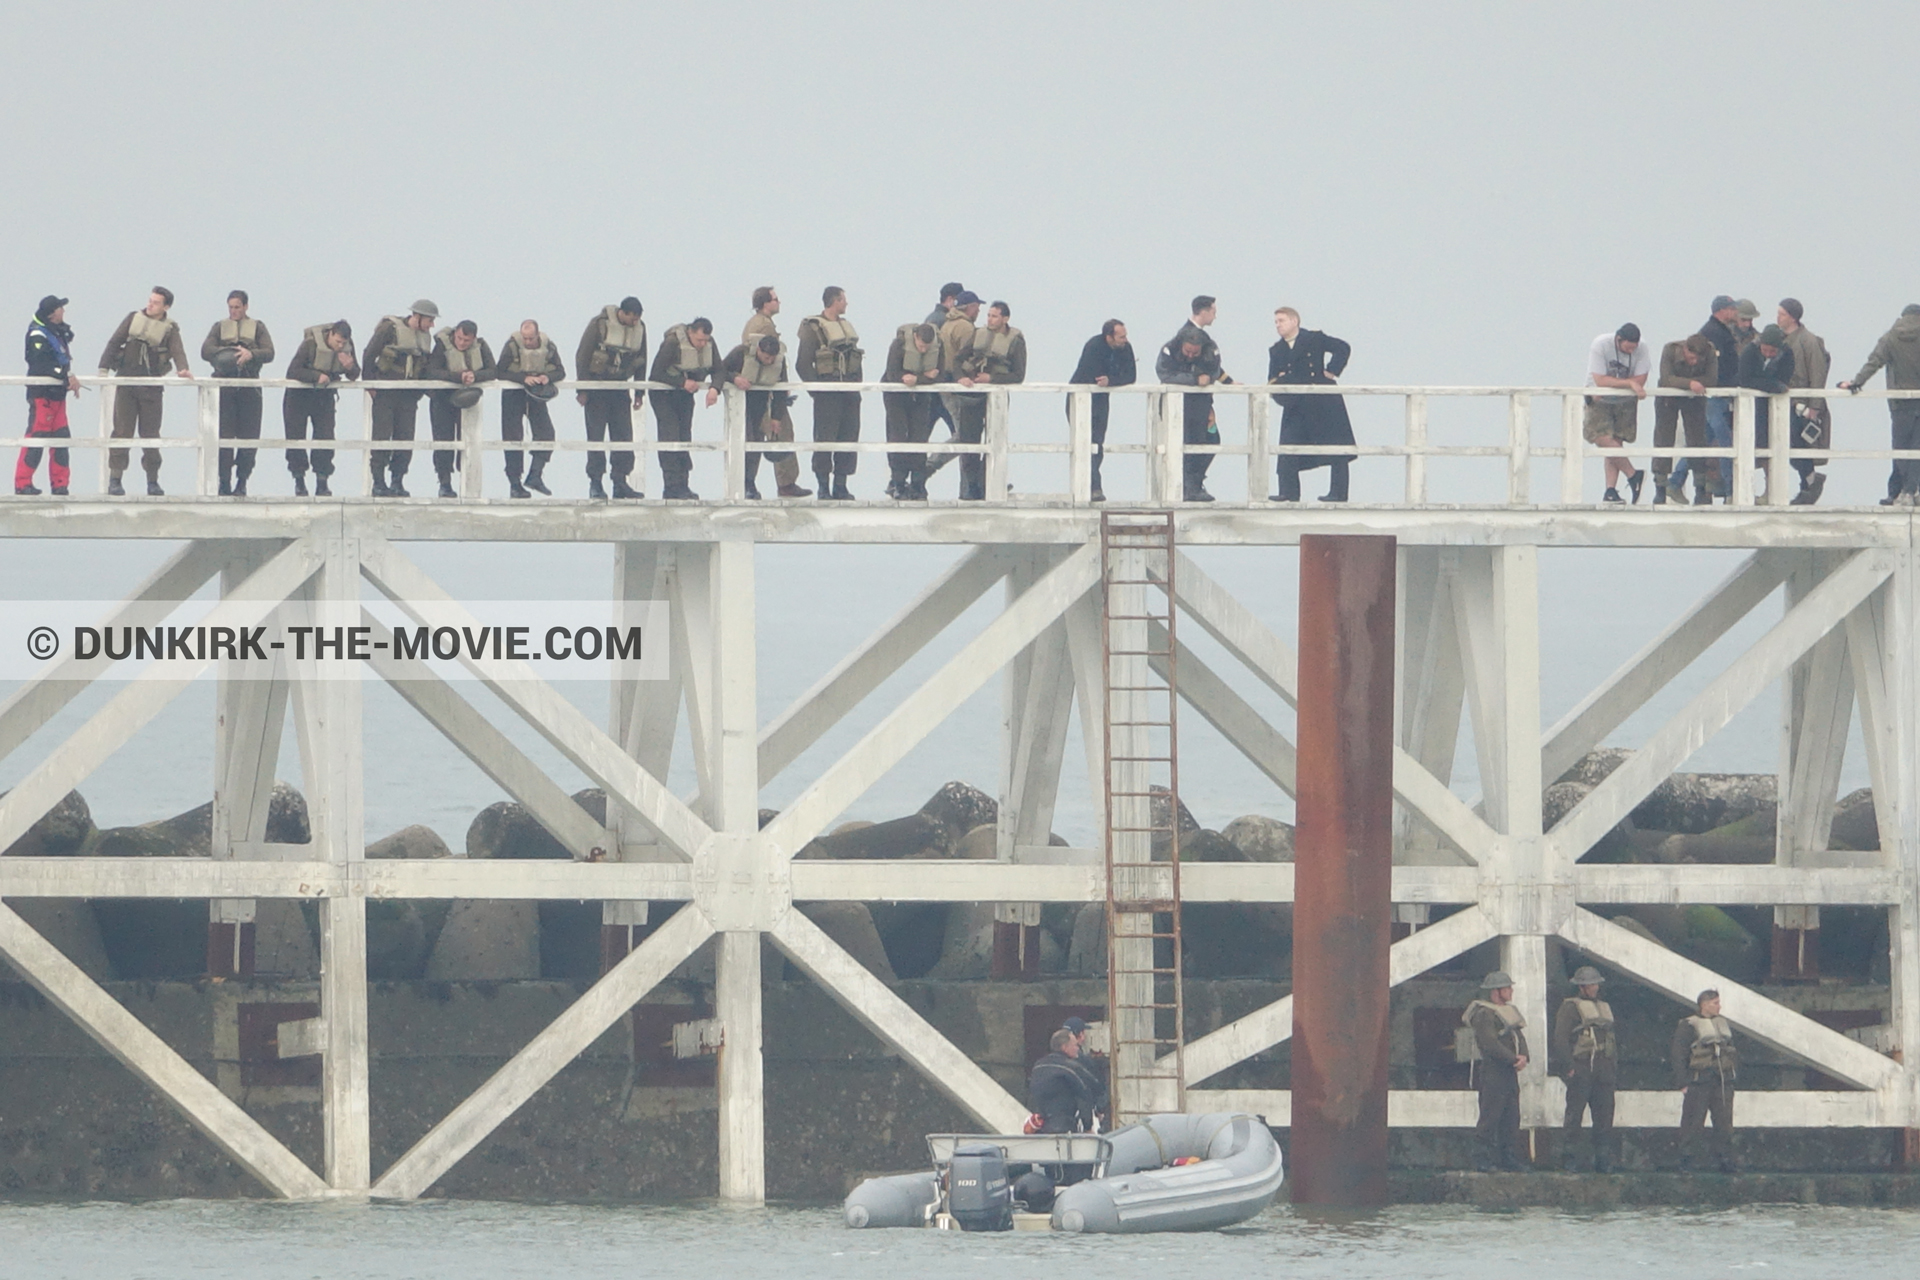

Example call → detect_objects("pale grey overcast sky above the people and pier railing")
0 2 1920 391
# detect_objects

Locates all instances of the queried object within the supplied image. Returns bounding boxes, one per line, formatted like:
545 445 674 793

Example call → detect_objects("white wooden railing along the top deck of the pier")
0 376 1920 507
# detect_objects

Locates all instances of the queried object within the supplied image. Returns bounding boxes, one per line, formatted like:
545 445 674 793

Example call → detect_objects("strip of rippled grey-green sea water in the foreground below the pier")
0 1201 1920 1280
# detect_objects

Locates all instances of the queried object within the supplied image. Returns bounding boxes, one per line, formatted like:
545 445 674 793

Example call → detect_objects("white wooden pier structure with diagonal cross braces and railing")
0 380 1920 1201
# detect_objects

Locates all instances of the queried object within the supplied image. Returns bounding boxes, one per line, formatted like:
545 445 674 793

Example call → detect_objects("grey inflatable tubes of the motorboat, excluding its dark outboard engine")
845 1113 1283 1232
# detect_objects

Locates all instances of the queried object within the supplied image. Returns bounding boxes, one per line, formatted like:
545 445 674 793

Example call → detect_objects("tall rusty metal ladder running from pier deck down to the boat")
1100 510 1187 1125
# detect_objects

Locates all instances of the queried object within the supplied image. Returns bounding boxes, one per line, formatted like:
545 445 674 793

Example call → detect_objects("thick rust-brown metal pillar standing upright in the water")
1288 535 1396 1207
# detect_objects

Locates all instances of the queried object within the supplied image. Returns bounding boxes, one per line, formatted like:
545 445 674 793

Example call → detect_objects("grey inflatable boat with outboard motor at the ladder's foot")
845 1115 1283 1232
